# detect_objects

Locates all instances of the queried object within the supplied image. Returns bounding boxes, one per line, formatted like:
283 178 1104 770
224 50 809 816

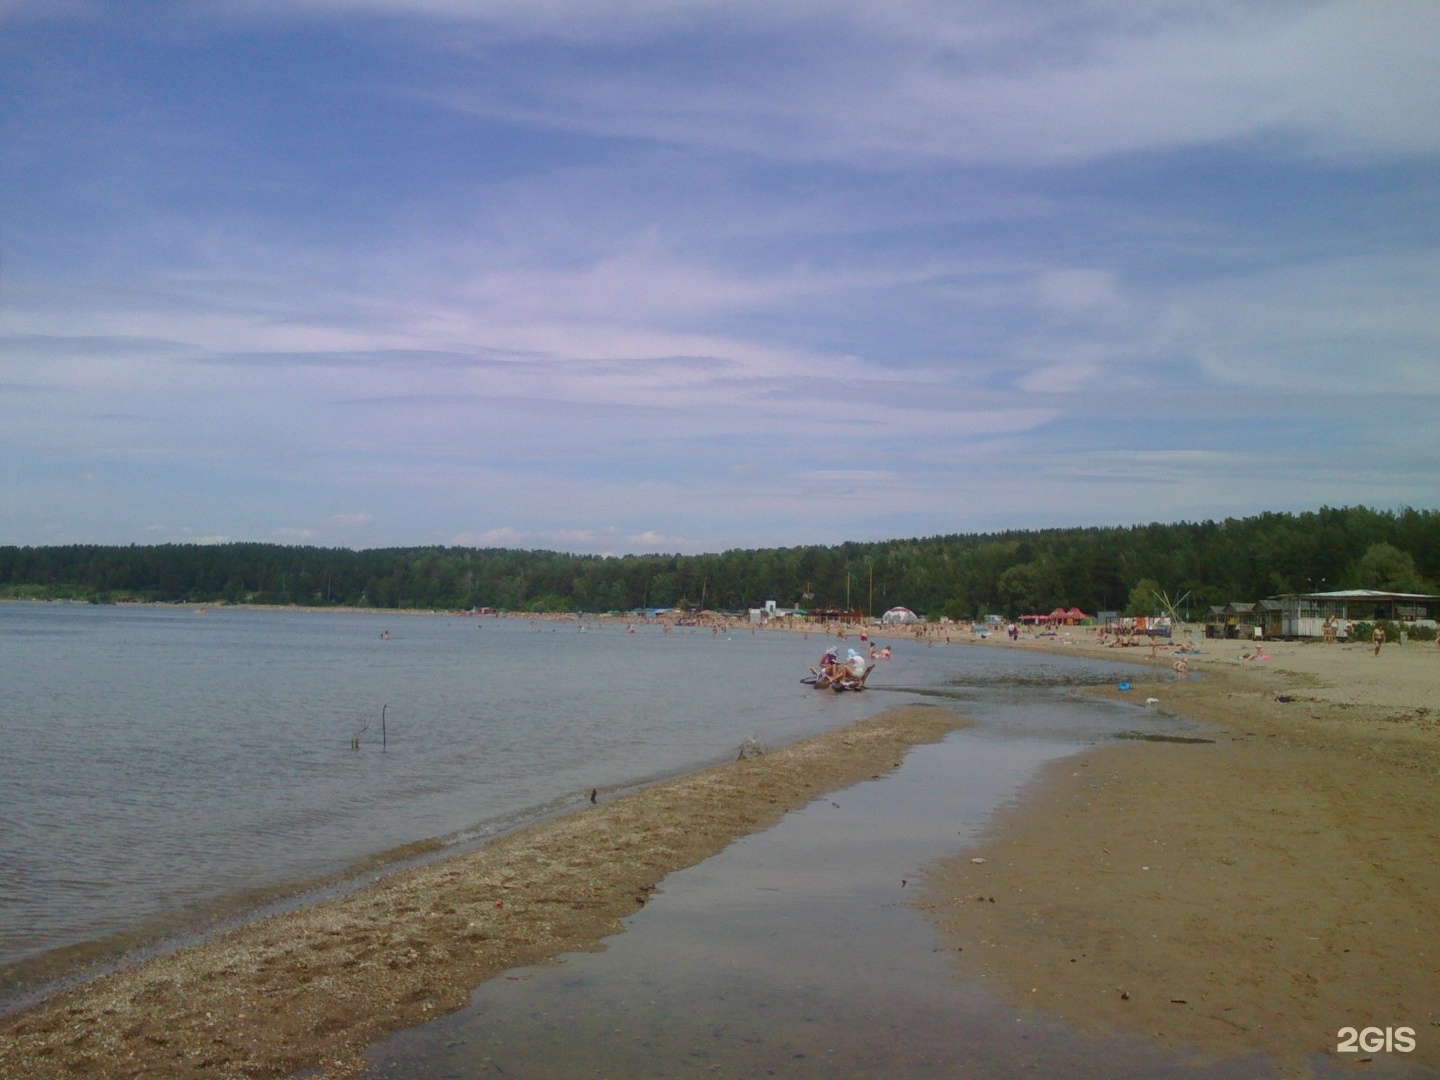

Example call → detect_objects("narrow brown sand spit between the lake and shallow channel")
0 707 966 1080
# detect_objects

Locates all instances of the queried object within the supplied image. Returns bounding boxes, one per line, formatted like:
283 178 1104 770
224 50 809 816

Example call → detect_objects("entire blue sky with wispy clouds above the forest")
0 0 1440 554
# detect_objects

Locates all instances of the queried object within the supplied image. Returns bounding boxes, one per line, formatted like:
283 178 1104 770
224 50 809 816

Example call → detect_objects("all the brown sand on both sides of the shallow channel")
0 631 1440 1079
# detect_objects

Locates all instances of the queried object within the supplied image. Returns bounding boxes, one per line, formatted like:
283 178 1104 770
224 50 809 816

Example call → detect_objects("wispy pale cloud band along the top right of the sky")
377 0 1440 168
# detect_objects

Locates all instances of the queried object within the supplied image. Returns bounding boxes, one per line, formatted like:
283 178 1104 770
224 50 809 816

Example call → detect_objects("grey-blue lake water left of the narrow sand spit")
0 603 1157 1005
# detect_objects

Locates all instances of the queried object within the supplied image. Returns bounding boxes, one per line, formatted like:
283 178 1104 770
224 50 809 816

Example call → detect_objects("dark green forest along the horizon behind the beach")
0 507 1440 619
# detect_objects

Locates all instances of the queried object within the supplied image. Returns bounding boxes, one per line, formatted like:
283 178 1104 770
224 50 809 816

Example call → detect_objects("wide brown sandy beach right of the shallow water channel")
924 634 1440 1076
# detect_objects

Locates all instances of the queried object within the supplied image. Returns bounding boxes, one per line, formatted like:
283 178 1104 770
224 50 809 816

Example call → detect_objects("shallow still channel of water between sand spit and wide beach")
362 733 1296 1080
